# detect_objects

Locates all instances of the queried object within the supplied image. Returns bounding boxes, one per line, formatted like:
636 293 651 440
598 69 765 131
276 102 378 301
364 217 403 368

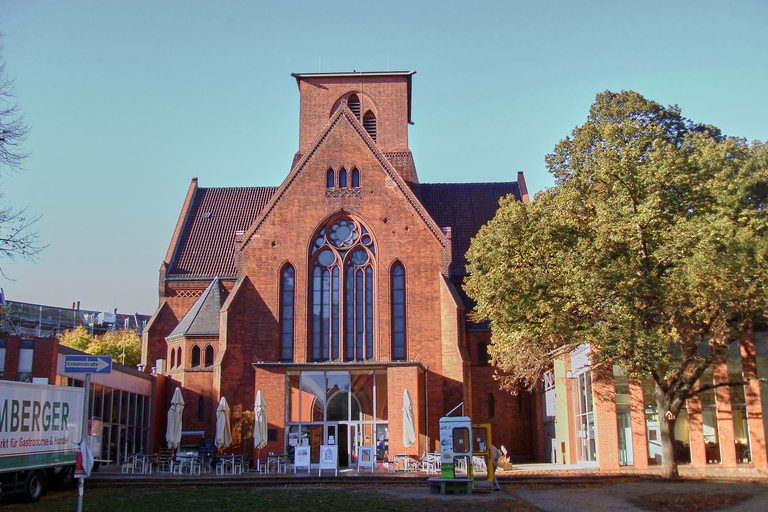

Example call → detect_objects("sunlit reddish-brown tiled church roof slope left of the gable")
168 187 277 278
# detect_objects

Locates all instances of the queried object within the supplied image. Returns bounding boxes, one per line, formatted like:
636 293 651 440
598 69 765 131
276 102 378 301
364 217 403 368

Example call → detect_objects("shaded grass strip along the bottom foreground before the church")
0 485 538 512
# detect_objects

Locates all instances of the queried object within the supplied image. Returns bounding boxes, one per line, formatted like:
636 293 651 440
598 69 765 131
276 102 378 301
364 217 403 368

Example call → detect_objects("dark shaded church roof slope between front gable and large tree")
417 181 523 276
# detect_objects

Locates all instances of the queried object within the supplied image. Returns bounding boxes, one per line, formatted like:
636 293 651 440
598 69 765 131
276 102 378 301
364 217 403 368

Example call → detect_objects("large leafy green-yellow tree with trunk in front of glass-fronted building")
465 91 768 477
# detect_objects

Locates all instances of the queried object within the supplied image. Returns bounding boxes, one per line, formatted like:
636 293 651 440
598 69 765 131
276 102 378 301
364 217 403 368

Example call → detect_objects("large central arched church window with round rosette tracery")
311 216 376 361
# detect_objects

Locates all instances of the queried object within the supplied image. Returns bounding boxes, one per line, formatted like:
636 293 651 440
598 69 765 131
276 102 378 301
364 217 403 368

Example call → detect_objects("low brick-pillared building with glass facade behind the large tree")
537 332 768 473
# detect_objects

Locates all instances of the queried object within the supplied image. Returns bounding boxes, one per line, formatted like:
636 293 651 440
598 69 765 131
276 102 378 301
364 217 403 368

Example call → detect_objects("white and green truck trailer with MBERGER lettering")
0 380 84 502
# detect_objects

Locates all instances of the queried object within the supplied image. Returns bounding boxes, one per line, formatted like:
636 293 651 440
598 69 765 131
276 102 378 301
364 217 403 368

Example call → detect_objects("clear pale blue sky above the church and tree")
0 0 768 314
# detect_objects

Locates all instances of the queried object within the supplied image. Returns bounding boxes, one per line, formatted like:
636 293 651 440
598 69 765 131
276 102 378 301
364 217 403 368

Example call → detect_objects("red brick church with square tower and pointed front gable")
143 71 543 467
